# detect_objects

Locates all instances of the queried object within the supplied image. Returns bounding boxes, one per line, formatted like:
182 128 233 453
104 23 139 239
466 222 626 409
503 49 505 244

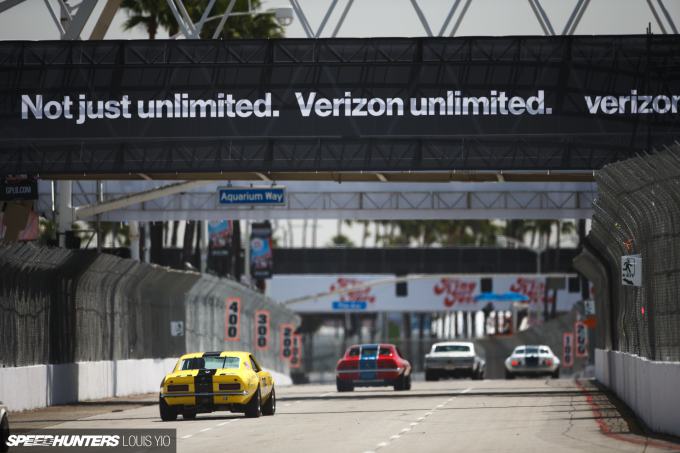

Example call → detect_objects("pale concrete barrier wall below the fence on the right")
595 349 680 436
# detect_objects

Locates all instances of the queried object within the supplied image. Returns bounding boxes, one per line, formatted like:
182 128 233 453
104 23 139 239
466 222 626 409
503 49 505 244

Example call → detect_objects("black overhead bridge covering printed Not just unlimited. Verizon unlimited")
0 35 680 173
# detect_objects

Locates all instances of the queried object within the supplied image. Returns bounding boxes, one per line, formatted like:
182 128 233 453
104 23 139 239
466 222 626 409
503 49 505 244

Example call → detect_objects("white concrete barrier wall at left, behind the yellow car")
0 358 292 412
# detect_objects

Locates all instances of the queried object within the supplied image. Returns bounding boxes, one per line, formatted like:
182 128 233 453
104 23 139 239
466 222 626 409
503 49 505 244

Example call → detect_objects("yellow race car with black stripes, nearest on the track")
159 351 276 421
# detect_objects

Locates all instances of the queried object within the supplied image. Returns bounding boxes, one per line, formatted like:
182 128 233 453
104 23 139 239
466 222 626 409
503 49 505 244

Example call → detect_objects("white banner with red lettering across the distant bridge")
267 274 582 313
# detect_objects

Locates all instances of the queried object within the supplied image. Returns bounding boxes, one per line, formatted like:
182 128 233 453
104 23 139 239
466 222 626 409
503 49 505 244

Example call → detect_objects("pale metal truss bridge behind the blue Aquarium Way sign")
36 181 596 221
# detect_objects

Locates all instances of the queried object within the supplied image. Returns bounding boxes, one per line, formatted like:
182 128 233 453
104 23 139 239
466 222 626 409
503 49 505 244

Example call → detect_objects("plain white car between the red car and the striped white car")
425 341 485 381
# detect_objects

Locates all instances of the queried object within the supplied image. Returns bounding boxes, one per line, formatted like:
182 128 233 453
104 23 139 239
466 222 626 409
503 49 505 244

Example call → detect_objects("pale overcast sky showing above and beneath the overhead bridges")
0 0 680 247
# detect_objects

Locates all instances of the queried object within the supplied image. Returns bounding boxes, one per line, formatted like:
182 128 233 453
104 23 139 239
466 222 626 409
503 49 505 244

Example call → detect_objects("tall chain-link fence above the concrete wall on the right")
588 144 680 361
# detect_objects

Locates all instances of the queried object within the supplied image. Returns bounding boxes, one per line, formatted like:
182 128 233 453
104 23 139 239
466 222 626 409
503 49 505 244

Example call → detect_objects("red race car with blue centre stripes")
335 344 411 392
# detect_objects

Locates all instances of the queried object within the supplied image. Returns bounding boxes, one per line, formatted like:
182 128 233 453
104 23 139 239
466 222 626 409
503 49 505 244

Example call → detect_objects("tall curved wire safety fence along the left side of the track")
0 244 299 372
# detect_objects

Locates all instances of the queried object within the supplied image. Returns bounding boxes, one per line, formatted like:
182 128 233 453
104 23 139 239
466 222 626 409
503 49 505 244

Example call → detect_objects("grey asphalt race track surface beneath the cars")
10 379 680 453
